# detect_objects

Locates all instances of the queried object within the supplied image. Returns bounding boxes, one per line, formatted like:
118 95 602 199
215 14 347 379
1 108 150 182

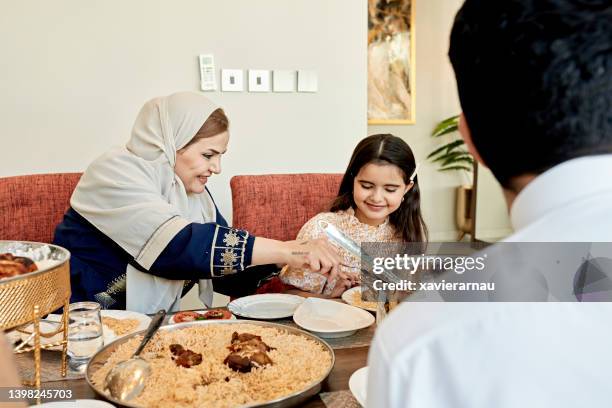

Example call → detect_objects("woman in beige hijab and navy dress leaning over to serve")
54 92 339 313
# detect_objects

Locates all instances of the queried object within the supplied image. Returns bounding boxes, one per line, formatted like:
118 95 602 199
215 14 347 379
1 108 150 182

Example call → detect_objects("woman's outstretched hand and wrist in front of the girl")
285 238 347 280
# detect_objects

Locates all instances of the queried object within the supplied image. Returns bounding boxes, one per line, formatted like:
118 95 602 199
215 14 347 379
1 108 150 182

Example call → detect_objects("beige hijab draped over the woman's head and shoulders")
70 92 218 313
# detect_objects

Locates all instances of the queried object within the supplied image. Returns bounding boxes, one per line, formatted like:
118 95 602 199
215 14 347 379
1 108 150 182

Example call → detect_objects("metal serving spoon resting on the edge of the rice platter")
104 309 166 401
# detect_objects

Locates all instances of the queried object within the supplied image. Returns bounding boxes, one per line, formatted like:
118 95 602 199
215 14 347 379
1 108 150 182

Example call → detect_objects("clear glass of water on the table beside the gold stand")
68 302 104 372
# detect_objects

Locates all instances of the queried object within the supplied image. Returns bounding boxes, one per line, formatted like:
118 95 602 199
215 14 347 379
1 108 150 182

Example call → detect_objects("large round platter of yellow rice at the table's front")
87 320 335 408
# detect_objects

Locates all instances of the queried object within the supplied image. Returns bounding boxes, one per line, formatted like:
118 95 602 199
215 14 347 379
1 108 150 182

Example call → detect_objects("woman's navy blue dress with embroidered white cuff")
53 199 277 309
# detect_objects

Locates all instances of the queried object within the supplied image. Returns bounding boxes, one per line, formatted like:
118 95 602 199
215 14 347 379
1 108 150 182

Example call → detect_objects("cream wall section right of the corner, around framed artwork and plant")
368 0 511 241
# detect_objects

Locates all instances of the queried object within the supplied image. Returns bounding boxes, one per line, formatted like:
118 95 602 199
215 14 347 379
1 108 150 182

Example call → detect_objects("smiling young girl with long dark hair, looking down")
280 134 427 297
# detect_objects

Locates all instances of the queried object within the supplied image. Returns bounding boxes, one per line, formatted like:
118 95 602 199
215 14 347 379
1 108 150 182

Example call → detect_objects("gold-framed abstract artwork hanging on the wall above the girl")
368 0 416 125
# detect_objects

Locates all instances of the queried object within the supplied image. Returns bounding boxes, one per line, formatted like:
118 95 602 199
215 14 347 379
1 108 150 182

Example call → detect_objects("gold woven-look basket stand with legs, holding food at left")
0 241 70 387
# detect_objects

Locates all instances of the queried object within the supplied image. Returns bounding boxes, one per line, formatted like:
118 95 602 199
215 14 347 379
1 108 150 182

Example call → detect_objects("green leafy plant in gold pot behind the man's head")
427 115 478 240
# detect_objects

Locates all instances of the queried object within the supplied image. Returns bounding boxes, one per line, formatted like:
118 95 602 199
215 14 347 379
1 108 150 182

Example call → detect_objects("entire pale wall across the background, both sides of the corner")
0 0 508 306
